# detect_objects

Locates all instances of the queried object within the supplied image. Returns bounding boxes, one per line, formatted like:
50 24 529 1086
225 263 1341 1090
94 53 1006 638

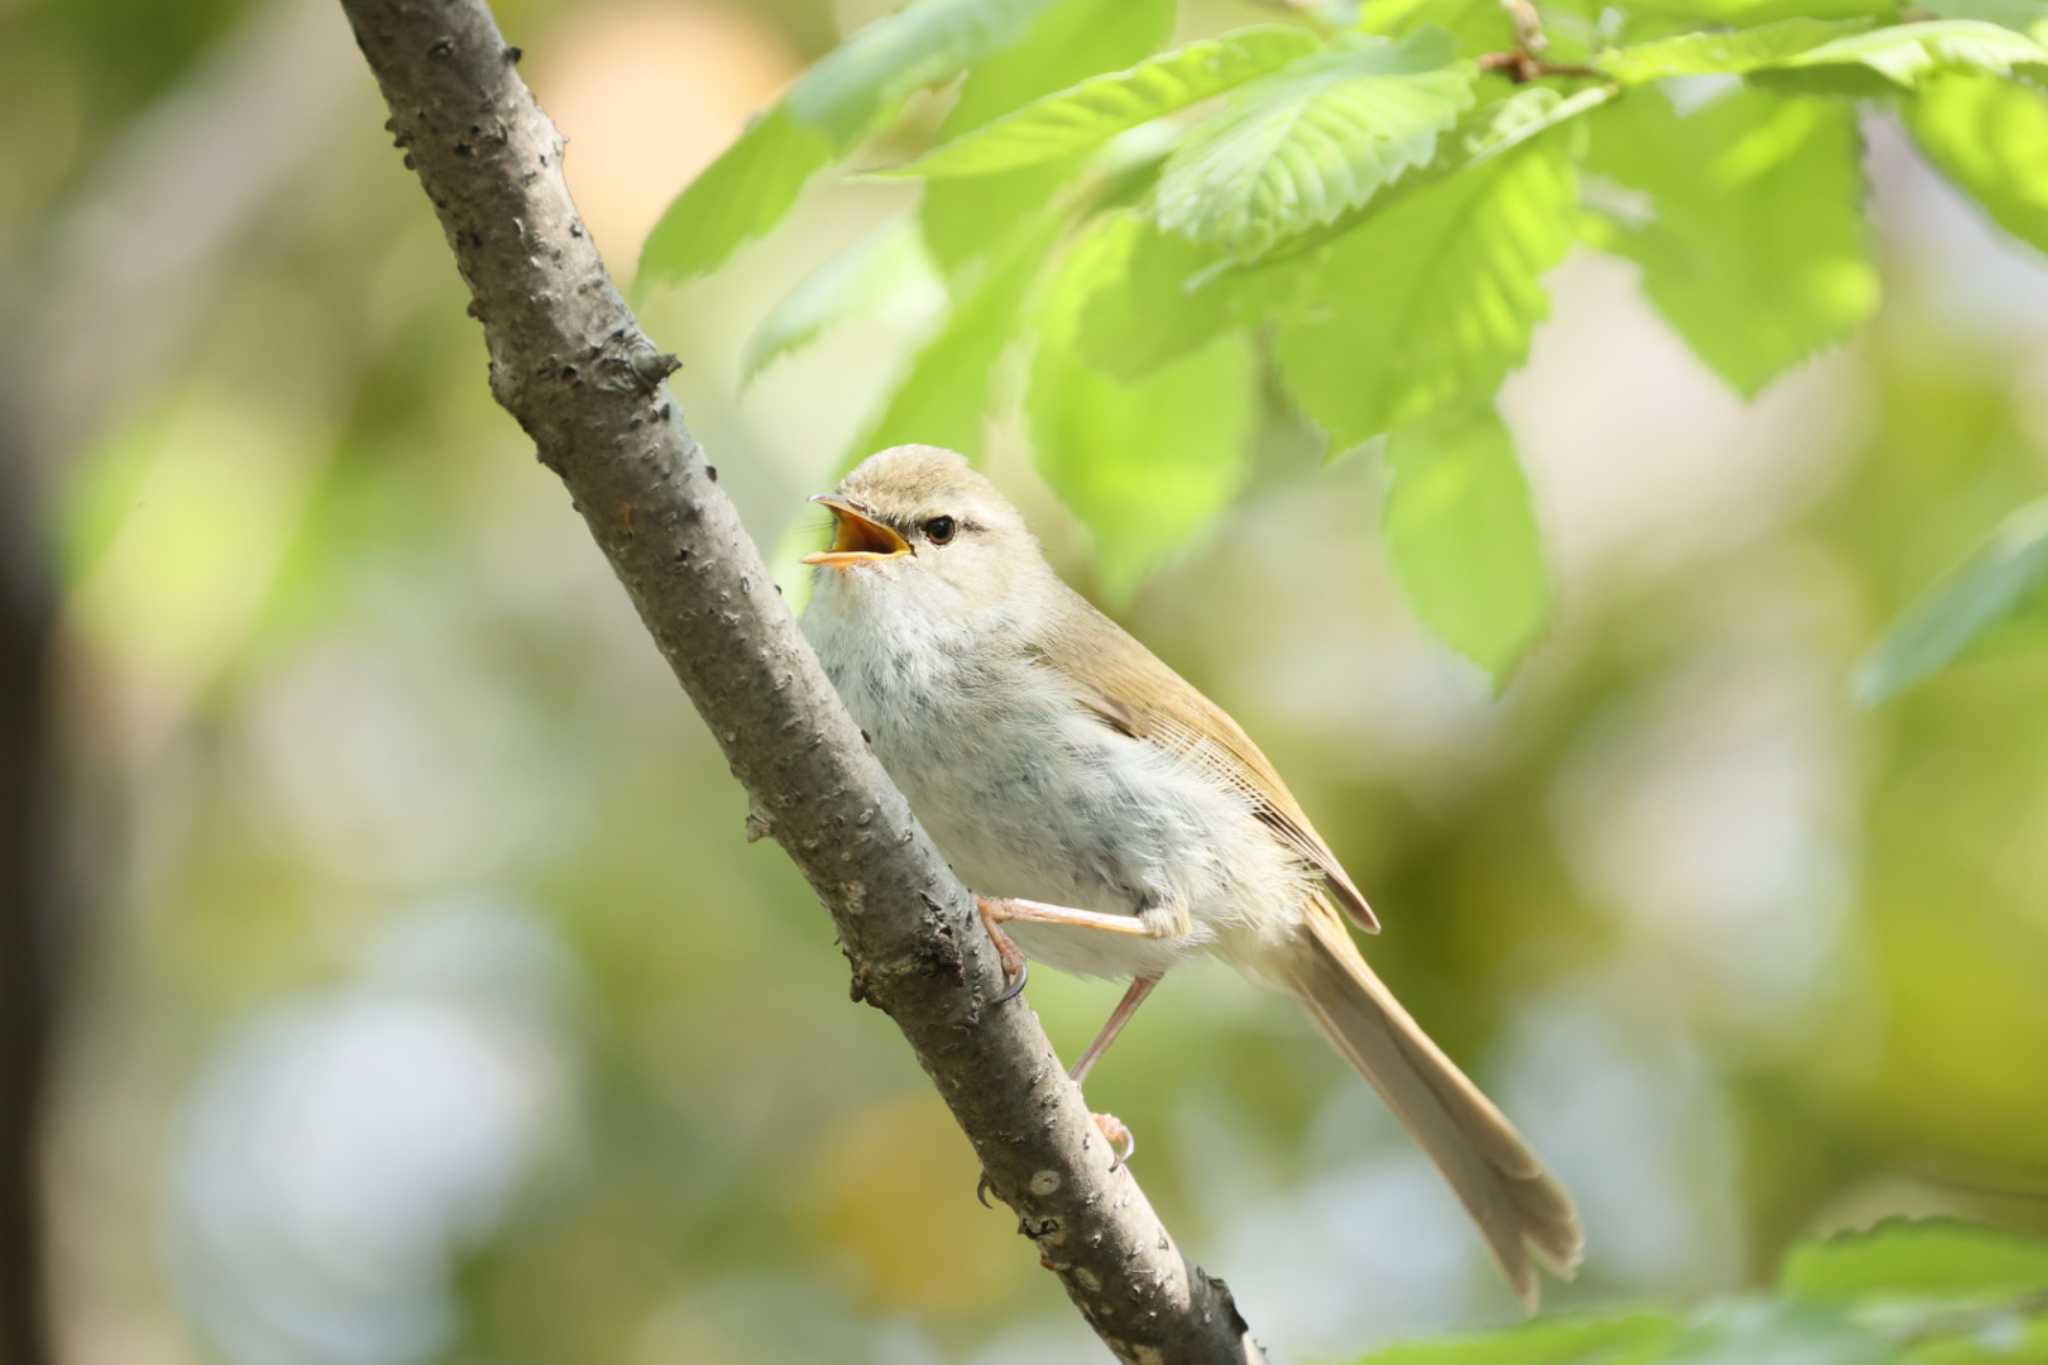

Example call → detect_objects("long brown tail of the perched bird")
1282 907 1585 1312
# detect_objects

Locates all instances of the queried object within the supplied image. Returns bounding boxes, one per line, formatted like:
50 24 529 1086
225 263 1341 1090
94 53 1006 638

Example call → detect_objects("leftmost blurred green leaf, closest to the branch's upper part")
633 106 840 291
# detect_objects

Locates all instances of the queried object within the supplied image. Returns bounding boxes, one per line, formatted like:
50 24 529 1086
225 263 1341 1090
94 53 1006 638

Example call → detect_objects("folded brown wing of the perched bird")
1034 593 1380 933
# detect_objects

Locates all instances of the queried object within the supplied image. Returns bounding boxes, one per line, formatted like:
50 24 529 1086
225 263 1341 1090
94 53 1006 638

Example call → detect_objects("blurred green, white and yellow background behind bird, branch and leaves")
0 0 2048 1365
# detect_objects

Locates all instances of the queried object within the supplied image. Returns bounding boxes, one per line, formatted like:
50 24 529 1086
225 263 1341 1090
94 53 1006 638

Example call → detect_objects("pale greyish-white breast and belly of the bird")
805 585 1307 976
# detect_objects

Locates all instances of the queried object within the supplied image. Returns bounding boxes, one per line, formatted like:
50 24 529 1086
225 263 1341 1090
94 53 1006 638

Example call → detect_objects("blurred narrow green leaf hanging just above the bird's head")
846 213 1057 467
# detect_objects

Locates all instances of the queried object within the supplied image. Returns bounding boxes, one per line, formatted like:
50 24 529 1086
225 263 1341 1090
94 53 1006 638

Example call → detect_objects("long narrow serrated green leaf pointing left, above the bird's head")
889 25 1319 180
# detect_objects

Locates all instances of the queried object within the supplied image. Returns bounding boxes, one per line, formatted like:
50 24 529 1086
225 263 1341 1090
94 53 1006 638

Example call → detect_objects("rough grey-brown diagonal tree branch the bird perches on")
342 0 1264 1365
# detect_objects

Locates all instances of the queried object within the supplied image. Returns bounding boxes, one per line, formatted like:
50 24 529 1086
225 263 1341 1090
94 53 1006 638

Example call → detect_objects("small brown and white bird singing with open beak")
803 444 1583 1312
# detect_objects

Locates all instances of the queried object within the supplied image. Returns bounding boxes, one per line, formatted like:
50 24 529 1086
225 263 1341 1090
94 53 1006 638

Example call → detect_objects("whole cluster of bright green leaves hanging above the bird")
641 0 2048 681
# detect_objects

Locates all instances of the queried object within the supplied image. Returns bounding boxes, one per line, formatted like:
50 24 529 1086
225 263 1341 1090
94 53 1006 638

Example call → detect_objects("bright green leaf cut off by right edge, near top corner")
1901 72 2048 252
